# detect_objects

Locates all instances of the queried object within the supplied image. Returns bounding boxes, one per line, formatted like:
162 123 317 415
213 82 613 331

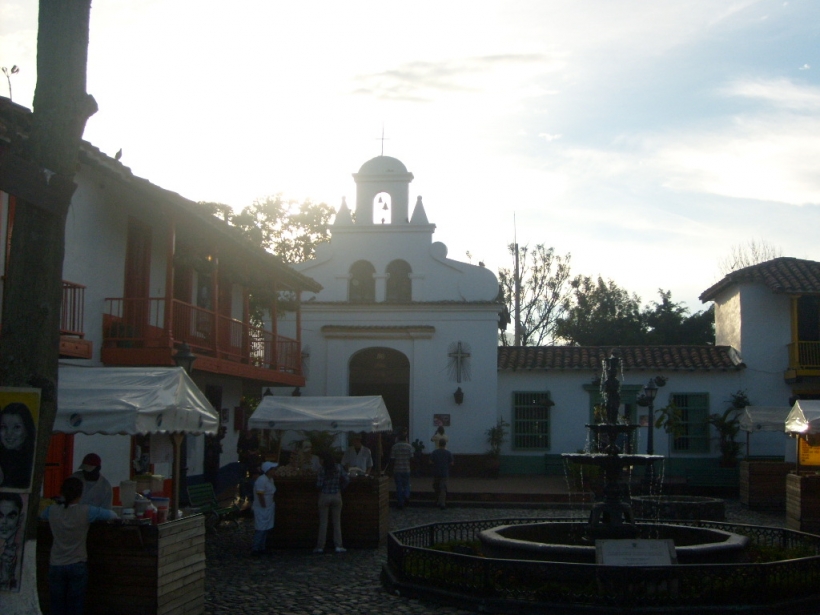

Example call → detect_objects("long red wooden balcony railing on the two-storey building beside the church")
103 298 301 374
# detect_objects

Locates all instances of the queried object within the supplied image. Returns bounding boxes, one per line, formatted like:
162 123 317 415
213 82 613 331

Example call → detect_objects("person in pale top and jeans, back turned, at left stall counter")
41 476 118 615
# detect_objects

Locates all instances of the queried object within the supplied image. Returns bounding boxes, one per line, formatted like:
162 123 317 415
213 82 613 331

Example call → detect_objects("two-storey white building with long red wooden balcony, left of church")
0 98 321 498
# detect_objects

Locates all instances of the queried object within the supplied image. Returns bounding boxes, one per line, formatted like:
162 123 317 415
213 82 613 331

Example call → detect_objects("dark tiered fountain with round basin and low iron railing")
382 357 820 615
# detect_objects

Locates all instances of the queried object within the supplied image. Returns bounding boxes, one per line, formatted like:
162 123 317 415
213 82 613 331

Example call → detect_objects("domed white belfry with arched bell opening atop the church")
353 156 413 225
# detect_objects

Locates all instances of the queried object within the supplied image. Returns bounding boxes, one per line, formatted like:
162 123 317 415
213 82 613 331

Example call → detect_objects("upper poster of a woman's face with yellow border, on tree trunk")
0 387 40 492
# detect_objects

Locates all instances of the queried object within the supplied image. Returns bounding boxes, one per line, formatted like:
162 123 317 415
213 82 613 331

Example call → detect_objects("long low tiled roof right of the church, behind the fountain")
498 346 745 371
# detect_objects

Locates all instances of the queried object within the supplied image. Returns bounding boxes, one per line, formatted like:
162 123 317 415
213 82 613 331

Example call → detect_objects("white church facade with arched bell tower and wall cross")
294 156 500 460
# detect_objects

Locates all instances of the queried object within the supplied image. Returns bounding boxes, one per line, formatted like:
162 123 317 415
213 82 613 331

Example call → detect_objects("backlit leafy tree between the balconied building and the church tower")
201 193 334 263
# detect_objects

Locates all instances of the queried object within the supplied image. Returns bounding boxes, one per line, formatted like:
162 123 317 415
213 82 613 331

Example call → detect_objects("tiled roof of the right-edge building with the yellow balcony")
700 256 820 302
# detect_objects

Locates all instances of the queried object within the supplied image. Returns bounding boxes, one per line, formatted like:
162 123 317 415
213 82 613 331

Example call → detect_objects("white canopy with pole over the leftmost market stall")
53 365 219 519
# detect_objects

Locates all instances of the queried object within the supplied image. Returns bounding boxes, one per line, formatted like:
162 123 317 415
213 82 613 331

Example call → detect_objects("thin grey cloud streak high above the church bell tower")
353 53 559 102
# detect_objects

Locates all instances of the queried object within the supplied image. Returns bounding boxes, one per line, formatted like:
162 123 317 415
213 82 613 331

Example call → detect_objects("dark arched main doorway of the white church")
348 347 410 432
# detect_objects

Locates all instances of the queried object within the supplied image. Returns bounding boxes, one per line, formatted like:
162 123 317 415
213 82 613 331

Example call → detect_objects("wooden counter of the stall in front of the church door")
268 476 390 549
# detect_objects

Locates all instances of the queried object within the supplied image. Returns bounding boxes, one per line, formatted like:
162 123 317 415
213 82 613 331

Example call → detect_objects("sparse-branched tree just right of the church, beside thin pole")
498 243 571 346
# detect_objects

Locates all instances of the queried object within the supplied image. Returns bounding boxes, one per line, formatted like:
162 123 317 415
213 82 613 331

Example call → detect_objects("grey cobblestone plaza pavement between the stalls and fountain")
205 500 785 615
